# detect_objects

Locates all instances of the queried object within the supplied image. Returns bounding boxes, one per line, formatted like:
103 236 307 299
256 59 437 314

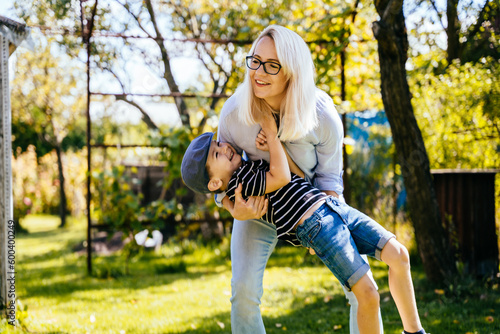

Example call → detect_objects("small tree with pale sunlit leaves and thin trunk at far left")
12 42 85 227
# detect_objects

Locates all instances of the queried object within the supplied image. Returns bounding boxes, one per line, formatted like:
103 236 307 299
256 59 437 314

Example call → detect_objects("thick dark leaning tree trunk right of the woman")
373 0 456 284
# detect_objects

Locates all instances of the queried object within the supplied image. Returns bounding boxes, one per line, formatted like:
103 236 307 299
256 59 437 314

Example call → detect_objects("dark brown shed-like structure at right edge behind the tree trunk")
431 169 500 277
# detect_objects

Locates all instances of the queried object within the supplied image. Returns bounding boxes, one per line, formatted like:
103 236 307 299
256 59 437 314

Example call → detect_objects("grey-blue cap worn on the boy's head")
181 132 214 193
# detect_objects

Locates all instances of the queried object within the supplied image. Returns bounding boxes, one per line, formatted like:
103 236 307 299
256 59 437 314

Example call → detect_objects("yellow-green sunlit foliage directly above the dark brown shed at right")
410 57 500 169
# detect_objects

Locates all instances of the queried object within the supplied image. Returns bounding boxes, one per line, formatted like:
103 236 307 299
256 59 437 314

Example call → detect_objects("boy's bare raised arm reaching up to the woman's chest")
260 115 292 194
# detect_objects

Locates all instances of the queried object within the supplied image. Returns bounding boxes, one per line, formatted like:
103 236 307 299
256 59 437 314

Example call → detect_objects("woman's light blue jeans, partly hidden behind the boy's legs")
231 215 383 334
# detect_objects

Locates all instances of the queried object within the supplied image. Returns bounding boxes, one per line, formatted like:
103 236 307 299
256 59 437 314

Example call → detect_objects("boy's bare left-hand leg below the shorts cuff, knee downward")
352 274 380 333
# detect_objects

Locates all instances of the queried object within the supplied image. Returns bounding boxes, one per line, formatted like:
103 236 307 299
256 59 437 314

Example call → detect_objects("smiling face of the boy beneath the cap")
206 141 241 184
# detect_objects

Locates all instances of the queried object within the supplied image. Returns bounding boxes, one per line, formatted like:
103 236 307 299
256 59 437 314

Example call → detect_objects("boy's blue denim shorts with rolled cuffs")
296 197 395 290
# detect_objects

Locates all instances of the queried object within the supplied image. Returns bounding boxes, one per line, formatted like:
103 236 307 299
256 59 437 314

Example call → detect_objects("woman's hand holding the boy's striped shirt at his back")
222 184 268 220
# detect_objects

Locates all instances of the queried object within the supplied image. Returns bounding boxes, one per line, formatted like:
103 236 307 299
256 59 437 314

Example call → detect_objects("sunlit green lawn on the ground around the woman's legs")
0 216 500 334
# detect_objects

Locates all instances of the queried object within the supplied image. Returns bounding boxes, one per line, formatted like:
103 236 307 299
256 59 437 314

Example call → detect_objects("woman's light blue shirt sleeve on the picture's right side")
312 99 344 195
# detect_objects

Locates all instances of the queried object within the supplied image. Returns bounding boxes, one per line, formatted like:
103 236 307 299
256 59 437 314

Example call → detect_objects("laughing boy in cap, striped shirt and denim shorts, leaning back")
181 116 425 334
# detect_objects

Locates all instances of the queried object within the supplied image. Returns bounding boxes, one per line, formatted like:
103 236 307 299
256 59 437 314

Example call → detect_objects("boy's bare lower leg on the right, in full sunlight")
381 238 422 333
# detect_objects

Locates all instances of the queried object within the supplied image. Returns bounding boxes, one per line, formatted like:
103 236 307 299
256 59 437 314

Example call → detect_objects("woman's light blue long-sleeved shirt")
217 89 344 201
